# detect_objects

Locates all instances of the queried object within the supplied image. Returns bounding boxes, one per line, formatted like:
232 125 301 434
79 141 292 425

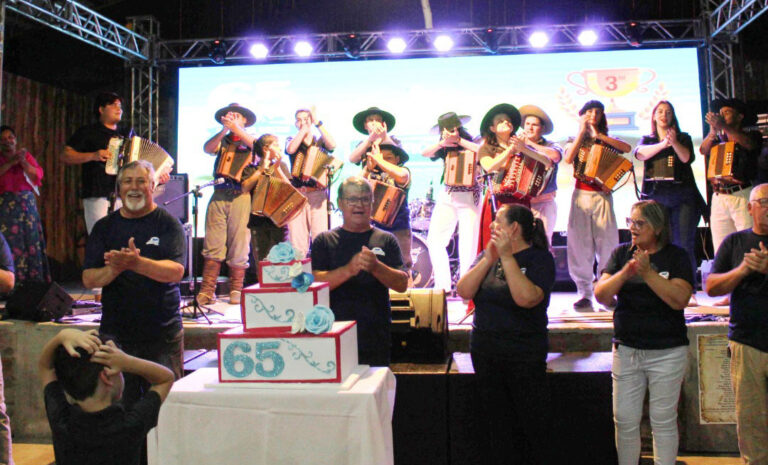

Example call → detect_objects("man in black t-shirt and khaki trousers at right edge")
706 184 768 465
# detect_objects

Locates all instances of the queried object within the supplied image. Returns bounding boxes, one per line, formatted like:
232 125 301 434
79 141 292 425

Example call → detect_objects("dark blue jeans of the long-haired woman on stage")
646 183 701 278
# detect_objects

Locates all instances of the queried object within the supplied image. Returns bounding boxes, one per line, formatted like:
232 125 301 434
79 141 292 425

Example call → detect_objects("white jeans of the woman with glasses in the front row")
611 344 688 465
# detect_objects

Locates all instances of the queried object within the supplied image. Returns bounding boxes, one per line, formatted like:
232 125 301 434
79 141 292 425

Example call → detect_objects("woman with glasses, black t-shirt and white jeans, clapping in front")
595 200 693 465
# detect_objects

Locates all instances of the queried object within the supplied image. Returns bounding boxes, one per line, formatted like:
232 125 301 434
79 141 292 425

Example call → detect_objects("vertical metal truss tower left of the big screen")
128 16 160 142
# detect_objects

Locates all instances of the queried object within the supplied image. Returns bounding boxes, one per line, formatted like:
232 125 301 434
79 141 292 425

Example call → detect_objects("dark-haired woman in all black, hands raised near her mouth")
456 204 555 464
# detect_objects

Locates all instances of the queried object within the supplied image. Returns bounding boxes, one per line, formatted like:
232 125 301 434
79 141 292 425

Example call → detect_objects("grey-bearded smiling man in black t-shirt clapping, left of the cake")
83 161 186 405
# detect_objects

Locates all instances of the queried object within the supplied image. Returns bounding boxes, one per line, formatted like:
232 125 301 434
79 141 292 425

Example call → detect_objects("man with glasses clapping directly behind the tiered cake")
311 177 408 366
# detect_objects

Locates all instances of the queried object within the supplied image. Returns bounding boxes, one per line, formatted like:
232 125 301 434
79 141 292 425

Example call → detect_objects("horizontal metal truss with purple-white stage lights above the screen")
156 20 707 64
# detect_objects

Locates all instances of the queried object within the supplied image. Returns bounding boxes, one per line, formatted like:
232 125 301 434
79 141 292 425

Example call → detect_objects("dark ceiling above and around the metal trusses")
4 0 768 94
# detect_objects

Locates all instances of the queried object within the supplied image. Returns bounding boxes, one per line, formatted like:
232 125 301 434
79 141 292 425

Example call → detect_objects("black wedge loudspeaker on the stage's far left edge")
6 281 73 321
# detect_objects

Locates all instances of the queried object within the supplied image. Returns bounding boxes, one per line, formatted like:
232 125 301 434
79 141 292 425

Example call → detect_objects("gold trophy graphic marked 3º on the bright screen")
565 68 656 129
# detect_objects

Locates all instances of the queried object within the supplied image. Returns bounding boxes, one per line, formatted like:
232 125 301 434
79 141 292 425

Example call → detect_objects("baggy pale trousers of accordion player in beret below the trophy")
567 189 619 299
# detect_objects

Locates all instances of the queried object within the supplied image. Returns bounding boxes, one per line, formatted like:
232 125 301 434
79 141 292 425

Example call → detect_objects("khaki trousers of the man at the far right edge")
728 341 768 465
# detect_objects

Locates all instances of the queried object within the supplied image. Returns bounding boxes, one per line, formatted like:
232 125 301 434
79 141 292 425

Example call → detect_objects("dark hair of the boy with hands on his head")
53 335 116 400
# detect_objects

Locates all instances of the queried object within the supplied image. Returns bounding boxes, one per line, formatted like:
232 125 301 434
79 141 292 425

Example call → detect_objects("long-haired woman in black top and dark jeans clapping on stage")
635 100 705 304
